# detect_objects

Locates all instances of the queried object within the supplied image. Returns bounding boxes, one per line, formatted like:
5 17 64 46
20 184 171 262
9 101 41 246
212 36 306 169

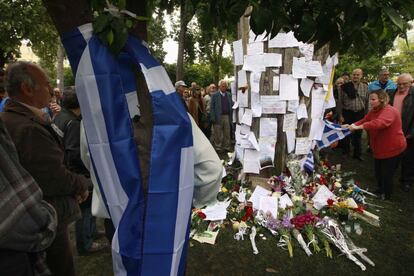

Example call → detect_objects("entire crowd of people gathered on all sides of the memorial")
0 58 414 275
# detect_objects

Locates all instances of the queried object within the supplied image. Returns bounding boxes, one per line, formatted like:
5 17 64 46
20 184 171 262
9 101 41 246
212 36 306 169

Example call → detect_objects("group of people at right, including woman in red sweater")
333 69 414 199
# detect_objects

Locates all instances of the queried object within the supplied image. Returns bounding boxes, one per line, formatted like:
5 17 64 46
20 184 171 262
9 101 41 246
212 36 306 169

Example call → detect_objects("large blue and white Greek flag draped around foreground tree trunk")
62 24 194 275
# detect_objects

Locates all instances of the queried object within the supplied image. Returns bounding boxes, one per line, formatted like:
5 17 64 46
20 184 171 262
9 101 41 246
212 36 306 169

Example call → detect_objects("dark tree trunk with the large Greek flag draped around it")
42 0 152 187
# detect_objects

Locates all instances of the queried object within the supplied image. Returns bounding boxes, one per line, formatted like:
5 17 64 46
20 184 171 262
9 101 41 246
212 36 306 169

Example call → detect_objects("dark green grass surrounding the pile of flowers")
75 146 414 276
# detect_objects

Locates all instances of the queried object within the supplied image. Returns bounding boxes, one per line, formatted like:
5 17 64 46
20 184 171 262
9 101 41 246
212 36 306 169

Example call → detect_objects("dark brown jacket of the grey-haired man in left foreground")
1 100 90 225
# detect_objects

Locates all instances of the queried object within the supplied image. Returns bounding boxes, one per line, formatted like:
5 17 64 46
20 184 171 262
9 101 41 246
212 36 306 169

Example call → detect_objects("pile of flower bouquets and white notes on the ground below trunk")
191 156 379 270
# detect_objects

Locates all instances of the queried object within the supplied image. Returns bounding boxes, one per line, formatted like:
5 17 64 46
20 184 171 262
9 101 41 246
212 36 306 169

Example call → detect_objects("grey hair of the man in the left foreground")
5 61 36 97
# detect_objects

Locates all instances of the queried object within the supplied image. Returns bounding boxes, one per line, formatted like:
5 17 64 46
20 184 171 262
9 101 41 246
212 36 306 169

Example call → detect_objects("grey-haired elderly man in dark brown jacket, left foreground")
1 61 91 275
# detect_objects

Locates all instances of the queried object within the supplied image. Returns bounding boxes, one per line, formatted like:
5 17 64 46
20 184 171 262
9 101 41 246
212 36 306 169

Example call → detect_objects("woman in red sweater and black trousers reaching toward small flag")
346 90 407 199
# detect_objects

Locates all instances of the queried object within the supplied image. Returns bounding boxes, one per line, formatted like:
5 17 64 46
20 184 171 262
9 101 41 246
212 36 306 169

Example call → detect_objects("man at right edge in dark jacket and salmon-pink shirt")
390 74 414 192
